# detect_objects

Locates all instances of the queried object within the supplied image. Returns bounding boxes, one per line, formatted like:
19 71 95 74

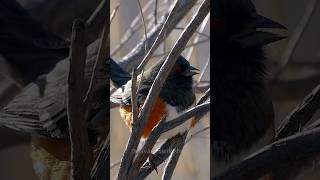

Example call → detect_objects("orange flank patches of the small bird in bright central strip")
120 97 167 138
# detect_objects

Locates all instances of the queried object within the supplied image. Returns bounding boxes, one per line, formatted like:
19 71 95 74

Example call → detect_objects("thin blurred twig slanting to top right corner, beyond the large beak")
273 0 319 79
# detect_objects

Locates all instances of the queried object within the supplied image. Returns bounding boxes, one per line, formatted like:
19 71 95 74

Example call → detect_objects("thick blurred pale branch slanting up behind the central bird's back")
119 0 197 72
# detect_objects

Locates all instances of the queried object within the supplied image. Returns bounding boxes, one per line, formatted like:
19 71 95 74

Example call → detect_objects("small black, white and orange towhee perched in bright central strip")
110 56 198 138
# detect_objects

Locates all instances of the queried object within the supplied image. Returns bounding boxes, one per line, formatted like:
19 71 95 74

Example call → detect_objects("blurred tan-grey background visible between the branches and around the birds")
0 0 320 180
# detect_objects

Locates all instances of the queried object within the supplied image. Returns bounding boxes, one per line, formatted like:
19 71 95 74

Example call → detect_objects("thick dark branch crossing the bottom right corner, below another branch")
213 128 320 180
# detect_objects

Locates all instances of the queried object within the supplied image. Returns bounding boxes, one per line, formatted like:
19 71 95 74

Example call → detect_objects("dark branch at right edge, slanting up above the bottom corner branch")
276 85 320 139
